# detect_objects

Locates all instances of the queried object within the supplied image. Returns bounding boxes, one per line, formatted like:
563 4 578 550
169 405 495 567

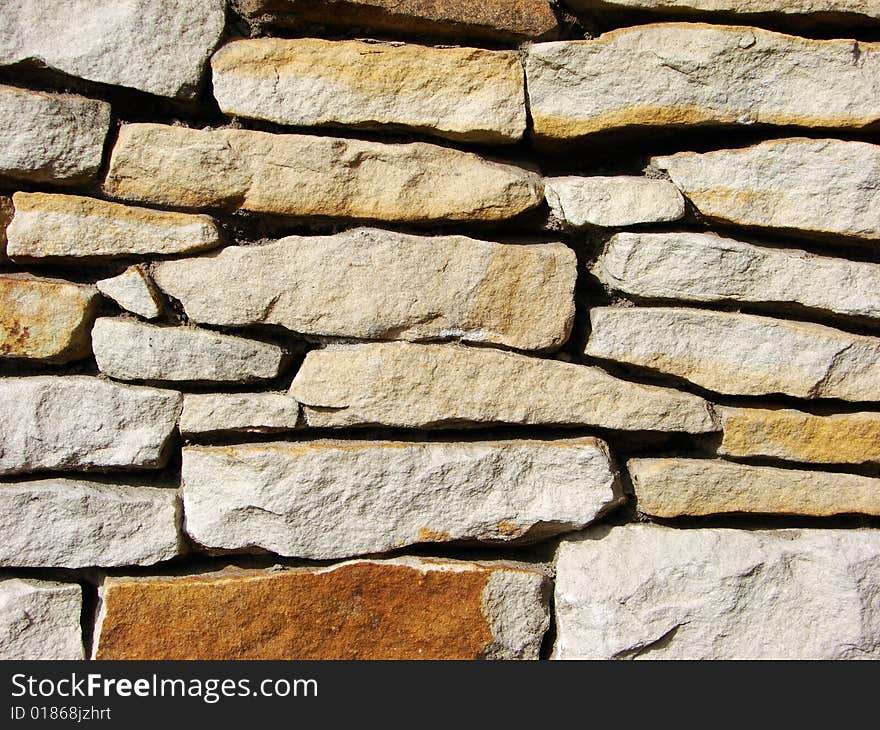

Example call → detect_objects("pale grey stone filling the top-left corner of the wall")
0 0 225 98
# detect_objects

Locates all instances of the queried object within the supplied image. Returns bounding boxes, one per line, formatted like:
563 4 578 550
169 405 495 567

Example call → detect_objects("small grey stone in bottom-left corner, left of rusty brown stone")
0 578 84 660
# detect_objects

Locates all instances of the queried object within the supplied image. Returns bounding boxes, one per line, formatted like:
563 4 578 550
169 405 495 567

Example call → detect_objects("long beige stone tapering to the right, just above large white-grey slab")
290 342 718 433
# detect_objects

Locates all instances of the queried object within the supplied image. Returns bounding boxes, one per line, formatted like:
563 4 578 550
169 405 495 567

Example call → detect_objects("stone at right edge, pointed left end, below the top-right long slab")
653 138 880 240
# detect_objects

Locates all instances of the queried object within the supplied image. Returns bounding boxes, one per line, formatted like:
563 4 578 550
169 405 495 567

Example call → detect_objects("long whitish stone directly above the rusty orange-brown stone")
183 438 623 559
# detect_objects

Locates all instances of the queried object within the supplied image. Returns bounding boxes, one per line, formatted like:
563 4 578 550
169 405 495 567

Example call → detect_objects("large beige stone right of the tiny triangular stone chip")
154 229 577 350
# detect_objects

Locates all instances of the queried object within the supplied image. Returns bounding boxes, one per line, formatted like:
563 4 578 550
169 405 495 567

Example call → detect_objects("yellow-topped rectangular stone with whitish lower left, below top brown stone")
211 38 526 144
